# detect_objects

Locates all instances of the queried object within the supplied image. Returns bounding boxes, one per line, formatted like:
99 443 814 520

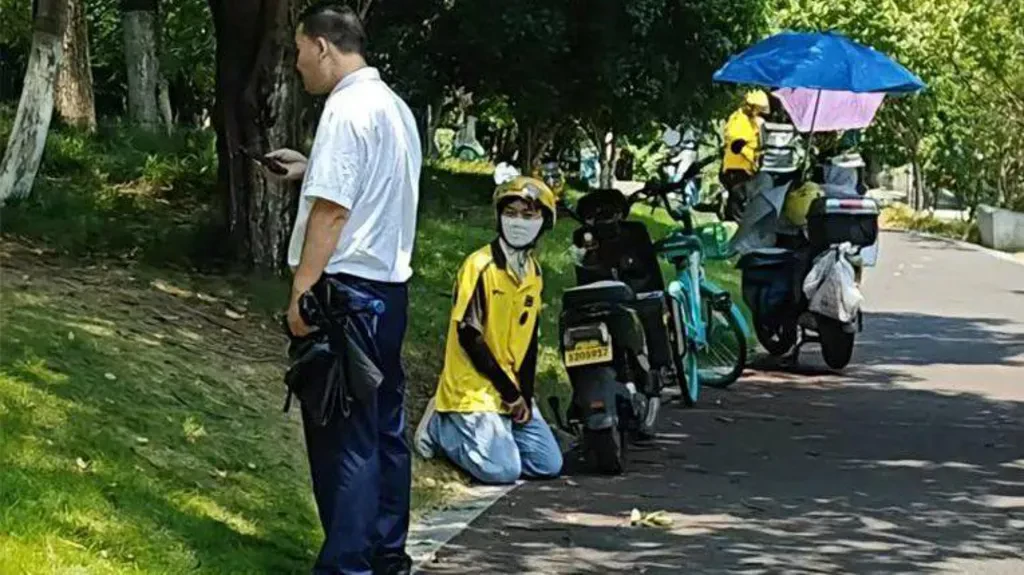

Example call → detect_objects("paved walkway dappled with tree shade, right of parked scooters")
417 233 1024 575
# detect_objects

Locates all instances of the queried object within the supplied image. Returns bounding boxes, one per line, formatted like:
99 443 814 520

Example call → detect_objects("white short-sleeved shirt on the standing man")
288 68 423 282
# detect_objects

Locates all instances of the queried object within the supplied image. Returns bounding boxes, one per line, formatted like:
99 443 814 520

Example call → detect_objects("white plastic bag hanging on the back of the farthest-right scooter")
804 244 864 323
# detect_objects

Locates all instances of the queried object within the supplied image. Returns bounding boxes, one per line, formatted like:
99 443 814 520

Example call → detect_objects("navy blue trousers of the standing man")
302 276 412 575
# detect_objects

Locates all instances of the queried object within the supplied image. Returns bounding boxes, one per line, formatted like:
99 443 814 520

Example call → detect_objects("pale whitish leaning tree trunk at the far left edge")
0 0 67 205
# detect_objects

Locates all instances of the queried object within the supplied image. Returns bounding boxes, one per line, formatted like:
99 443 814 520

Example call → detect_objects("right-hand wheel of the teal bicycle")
696 299 746 389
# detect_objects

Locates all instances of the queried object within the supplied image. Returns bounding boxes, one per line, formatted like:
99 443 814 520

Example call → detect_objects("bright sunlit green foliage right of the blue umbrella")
775 0 1024 209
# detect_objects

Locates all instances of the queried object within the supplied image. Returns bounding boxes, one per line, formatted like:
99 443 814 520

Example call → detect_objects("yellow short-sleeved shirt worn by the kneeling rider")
436 241 544 413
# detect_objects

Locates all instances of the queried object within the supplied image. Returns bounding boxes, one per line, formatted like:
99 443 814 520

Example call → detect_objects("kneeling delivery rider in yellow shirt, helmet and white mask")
414 171 562 484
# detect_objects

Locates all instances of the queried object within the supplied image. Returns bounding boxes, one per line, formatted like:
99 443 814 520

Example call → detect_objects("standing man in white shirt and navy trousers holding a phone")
267 2 422 575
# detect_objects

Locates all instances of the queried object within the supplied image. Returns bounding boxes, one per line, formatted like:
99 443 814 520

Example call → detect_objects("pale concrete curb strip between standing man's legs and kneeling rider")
406 481 523 574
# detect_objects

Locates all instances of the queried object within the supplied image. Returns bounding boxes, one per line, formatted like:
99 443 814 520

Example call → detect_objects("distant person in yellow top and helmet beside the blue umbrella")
719 90 770 221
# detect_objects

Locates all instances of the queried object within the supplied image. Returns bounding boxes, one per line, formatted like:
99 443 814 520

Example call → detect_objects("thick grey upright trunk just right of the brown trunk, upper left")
122 0 160 130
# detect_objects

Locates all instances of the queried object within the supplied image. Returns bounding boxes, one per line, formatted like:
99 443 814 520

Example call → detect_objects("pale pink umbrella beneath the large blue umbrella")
774 88 885 132
